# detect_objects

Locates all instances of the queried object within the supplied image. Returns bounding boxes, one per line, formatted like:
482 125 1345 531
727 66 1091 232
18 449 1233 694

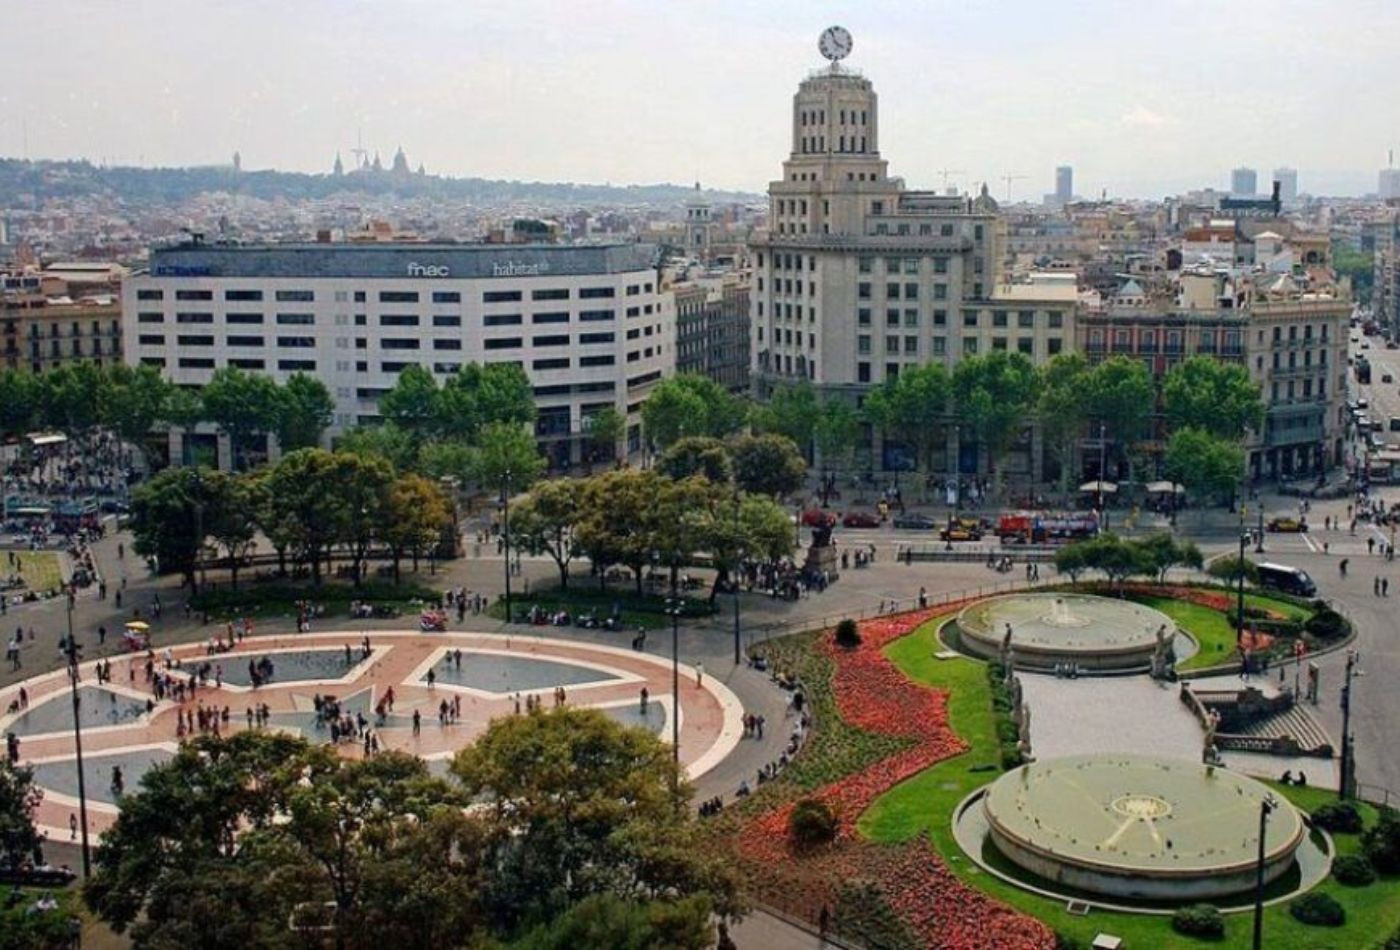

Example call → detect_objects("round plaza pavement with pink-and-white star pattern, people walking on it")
0 630 743 842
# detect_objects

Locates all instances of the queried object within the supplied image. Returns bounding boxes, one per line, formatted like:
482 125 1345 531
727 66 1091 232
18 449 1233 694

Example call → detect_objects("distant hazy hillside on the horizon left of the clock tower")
0 158 763 207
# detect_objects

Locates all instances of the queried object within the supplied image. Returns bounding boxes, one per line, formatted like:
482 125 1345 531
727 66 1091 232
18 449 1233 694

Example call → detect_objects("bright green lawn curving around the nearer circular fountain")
858 615 1400 950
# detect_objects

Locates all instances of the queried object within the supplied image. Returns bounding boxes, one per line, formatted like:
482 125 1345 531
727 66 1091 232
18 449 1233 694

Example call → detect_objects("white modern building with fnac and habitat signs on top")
122 242 675 467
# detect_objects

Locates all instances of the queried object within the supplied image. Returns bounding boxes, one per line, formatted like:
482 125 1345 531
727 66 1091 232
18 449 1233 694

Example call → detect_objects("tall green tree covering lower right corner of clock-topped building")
952 350 1036 485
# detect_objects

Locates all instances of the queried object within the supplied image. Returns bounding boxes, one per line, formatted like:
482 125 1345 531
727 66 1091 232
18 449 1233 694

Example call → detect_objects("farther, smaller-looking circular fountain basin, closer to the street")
945 593 1191 673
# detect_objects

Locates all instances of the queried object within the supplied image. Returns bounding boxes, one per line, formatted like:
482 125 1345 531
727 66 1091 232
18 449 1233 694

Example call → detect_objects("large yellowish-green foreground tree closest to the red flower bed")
452 707 741 929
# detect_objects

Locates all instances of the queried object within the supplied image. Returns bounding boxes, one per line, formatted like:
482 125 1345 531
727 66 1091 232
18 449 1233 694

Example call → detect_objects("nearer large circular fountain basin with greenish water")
981 754 1306 901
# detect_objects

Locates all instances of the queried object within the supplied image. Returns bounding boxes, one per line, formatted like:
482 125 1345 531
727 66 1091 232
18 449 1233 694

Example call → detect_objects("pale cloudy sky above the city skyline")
0 0 1400 200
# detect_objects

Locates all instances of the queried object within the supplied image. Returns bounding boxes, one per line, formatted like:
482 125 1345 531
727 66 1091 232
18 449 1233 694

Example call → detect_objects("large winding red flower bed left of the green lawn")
739 604 1054 949
